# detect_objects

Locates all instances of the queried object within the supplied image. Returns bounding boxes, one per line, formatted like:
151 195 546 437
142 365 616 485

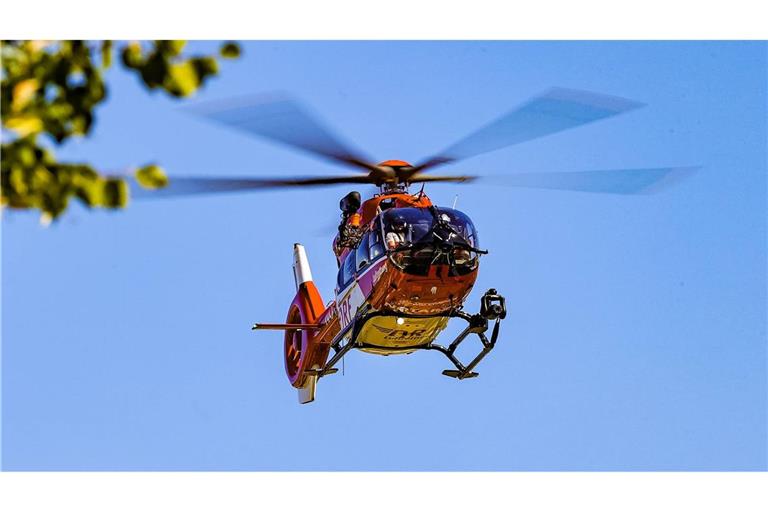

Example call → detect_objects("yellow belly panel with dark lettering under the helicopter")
358 316 448 354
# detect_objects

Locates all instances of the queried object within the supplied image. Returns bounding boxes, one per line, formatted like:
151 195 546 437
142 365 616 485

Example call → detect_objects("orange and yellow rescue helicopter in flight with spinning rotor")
138 88 695 404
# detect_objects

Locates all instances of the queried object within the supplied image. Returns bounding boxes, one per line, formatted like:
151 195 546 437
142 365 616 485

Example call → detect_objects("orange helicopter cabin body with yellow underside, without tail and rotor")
334 193 479 355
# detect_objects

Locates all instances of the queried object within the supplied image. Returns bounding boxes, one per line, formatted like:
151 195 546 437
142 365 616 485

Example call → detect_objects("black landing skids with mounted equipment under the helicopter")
310 288 507 382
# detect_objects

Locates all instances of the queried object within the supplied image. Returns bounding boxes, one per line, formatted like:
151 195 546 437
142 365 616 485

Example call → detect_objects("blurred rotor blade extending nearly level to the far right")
476 167 699 194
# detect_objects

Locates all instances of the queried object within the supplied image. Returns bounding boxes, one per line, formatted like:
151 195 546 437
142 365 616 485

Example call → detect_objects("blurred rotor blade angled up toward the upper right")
412 88 643 173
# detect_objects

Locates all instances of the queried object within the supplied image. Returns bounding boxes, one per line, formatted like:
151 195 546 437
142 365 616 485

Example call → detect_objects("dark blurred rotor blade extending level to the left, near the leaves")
131 176 371 199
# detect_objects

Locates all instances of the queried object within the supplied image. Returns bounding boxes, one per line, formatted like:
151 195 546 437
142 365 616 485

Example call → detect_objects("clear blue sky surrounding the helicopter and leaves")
2 42 768 470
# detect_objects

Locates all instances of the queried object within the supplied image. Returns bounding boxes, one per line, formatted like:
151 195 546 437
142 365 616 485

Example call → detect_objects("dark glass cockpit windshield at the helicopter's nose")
376 206 484 275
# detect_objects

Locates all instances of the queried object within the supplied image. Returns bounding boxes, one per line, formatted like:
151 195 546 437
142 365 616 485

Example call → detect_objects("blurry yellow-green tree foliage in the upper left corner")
0 40 241 218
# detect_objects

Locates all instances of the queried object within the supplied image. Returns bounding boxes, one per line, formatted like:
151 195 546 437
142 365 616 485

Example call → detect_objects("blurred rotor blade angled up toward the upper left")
186 97 376 171
